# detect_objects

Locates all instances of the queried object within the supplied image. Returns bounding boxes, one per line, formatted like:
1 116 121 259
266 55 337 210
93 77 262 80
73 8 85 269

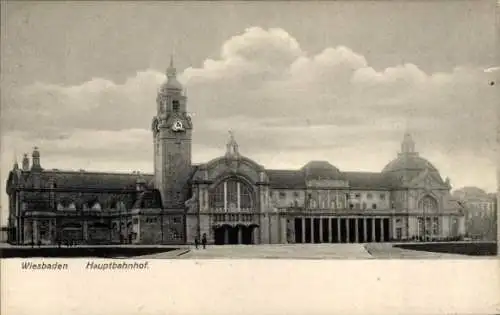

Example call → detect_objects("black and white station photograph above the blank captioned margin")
0 1 500 259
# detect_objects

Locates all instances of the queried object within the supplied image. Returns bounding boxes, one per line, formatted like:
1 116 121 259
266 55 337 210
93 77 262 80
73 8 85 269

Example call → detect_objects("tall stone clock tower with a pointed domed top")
151 58 193 210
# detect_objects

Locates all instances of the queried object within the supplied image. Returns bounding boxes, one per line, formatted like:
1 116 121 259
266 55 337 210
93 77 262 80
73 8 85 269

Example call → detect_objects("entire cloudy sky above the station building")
0 1 499 223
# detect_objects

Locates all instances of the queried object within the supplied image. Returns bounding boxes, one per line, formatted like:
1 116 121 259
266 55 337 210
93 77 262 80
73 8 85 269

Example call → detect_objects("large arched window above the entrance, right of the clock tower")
210 179 253 211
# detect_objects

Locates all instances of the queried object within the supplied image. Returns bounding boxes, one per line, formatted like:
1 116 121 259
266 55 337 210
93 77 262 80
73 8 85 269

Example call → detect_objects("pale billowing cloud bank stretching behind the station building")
1 27 497 199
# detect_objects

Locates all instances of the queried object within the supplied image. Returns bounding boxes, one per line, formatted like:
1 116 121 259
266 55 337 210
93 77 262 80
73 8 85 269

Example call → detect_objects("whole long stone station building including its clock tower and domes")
2 59 465 244
